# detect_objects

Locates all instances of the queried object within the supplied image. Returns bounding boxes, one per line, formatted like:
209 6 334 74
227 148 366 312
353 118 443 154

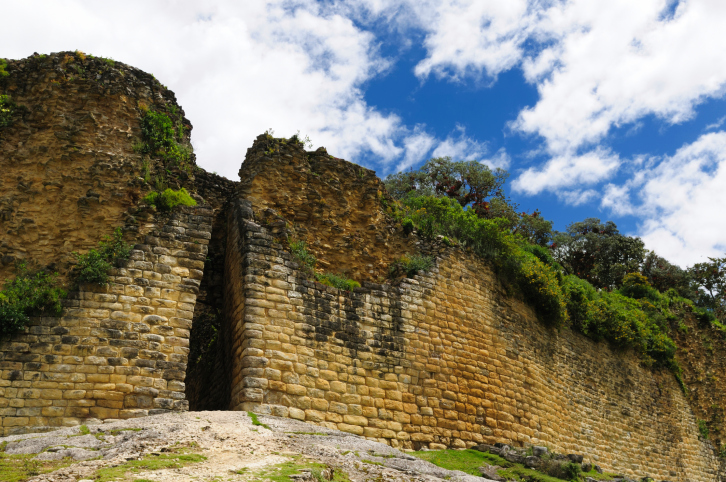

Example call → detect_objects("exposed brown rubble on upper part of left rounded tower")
0 52 199 281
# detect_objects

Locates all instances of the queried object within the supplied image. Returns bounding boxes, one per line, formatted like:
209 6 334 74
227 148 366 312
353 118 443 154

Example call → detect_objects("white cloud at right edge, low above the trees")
632 131 726 266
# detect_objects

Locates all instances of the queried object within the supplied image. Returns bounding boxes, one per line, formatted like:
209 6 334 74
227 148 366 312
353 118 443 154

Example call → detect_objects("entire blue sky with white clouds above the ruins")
0 0 726 266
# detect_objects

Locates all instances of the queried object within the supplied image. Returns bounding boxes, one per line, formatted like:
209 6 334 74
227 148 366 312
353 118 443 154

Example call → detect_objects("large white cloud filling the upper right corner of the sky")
514 0 726 153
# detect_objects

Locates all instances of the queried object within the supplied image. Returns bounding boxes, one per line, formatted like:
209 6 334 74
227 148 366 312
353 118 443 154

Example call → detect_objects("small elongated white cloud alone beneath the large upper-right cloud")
512 148 620 194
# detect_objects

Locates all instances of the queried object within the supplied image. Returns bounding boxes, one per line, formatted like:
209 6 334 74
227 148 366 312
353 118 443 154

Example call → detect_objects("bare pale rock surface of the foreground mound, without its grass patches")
0 412 500 482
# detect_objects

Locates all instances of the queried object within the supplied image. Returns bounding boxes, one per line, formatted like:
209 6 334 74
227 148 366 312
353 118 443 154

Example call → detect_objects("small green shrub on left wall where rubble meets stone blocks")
73 228 131 285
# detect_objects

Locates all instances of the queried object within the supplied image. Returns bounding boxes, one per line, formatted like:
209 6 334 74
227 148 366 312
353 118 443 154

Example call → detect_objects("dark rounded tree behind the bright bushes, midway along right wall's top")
551 218 645 289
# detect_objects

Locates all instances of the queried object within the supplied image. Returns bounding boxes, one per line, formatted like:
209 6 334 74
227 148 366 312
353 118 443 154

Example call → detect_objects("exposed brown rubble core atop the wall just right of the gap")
237 134 416 280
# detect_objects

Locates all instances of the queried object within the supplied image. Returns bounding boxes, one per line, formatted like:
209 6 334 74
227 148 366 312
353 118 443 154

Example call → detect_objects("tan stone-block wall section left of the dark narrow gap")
0 206 212 435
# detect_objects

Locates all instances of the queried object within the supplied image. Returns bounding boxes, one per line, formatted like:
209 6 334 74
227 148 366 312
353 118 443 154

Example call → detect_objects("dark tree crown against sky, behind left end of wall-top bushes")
384 157 552 246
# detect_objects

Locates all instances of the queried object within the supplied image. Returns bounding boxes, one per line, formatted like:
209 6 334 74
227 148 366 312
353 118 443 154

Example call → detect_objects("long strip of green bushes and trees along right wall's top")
381 158 726 374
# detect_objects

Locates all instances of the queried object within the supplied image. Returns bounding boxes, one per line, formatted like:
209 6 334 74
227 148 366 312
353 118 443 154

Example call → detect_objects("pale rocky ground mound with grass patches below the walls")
0 412 489 482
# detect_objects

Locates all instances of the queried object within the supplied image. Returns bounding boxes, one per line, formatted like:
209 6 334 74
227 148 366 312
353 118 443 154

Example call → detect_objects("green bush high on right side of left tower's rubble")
140 108 192 168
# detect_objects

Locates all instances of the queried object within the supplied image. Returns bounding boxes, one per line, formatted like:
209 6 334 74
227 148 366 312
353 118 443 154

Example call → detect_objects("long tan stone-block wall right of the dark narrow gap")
227 201 718 482
